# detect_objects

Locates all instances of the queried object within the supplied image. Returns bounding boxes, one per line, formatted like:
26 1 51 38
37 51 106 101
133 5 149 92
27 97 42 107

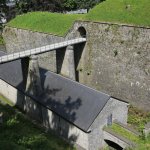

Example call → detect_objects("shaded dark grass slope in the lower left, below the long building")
0 96 74 150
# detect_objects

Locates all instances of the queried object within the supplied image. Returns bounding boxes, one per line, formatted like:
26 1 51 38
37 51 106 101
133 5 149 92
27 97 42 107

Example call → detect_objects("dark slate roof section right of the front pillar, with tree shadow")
40 72 110 131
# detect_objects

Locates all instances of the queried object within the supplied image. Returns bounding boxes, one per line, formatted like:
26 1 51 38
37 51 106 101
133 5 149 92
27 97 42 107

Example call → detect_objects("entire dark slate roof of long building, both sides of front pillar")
0 51 110 132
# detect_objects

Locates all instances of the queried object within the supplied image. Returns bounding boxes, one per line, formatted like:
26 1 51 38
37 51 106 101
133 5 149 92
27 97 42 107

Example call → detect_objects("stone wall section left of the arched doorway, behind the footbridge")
3 26 64 72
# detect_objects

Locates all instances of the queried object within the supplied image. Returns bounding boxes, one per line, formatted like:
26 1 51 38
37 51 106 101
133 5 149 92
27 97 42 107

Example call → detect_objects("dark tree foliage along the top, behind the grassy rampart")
0 0 103 21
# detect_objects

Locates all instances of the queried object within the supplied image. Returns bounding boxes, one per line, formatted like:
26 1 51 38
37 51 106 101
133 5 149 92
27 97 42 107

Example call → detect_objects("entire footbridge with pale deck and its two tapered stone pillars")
0 38 86 96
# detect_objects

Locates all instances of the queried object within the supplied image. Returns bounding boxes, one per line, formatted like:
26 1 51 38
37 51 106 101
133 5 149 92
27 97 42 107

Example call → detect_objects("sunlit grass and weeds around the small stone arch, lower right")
107 106 150 150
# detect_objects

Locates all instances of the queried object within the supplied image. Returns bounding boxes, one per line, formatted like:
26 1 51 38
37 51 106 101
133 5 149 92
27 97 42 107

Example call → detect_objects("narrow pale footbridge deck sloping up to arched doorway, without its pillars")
0 38 86 64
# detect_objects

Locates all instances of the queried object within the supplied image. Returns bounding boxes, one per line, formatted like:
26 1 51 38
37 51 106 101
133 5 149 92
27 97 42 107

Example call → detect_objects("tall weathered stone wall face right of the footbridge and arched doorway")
70 21 150 111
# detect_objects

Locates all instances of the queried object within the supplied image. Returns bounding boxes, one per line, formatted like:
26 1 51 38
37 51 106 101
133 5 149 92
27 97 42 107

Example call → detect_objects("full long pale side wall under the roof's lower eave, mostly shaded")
0 79 88 150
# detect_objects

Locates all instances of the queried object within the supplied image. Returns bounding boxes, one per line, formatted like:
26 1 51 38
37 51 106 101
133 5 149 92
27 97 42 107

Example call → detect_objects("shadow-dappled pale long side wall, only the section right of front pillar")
42 107 88 149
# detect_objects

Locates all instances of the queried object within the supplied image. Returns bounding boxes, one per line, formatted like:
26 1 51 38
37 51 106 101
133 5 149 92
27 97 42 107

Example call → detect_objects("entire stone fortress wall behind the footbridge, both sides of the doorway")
3 21 150 110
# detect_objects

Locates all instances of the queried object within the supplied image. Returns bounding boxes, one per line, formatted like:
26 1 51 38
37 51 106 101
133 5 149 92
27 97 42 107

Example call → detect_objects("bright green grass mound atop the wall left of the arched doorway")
8 12 83 36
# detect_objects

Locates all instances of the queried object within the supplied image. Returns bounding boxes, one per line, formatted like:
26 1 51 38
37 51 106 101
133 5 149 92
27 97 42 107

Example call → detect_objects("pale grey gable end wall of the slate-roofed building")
89 98 128 150
